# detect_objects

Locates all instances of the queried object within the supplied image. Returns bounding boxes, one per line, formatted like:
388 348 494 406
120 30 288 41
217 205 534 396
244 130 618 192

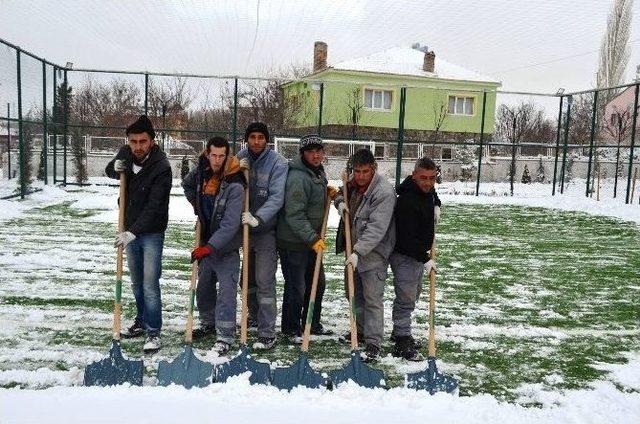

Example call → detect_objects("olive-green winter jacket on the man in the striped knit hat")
276 156 327 251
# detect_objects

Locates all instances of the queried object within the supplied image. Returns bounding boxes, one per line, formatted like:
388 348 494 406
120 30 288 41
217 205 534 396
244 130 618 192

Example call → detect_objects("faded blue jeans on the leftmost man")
126 233 164 336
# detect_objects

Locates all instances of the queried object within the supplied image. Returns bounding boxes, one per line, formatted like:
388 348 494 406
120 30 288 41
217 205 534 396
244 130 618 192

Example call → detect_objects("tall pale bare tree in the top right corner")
596 0 633 104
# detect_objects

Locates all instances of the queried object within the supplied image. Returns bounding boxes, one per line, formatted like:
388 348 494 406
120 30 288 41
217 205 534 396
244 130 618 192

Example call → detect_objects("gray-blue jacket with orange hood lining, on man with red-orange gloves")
182 154 246 254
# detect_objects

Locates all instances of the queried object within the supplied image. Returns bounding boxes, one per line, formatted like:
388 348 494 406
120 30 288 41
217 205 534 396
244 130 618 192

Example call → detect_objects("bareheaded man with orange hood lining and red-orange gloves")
182 137 245 355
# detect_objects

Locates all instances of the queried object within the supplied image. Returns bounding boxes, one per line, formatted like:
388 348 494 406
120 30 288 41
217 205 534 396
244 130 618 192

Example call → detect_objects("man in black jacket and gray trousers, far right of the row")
389 157 440 361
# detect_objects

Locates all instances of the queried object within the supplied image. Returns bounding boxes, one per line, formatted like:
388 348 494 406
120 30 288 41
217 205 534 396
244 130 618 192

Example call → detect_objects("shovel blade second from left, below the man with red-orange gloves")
158 345 213 389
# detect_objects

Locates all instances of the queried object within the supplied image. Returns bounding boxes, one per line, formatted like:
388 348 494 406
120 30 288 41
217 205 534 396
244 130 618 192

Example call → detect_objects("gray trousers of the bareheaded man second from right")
354 263 387 348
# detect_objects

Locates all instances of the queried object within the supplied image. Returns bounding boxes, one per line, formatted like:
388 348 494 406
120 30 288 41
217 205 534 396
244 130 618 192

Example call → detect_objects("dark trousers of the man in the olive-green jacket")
278 249 325 335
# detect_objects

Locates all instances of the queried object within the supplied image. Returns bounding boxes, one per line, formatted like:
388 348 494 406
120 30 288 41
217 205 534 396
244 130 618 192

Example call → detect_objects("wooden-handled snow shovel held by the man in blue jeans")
84 172 143 386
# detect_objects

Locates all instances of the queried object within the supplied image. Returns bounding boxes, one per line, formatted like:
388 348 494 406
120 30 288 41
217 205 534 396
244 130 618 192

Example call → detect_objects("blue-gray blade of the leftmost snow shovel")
84 340 143 386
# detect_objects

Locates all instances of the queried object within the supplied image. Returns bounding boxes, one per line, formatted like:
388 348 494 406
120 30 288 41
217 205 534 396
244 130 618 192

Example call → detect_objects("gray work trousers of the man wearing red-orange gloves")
196 250 240 343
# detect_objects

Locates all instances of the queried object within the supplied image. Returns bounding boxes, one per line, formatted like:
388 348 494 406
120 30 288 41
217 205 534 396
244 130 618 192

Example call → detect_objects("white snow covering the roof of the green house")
331 47 500 84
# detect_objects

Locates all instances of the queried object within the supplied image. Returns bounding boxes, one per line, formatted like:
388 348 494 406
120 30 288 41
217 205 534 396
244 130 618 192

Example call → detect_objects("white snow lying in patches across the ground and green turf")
0 177 640 424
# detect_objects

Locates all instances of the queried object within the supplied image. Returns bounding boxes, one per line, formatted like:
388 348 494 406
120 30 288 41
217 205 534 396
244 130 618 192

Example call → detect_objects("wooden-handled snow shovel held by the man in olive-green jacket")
273 196 331 390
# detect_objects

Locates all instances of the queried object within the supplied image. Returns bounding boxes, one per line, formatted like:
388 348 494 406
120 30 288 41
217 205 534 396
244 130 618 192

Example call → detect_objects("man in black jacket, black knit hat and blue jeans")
105 115 172 353
